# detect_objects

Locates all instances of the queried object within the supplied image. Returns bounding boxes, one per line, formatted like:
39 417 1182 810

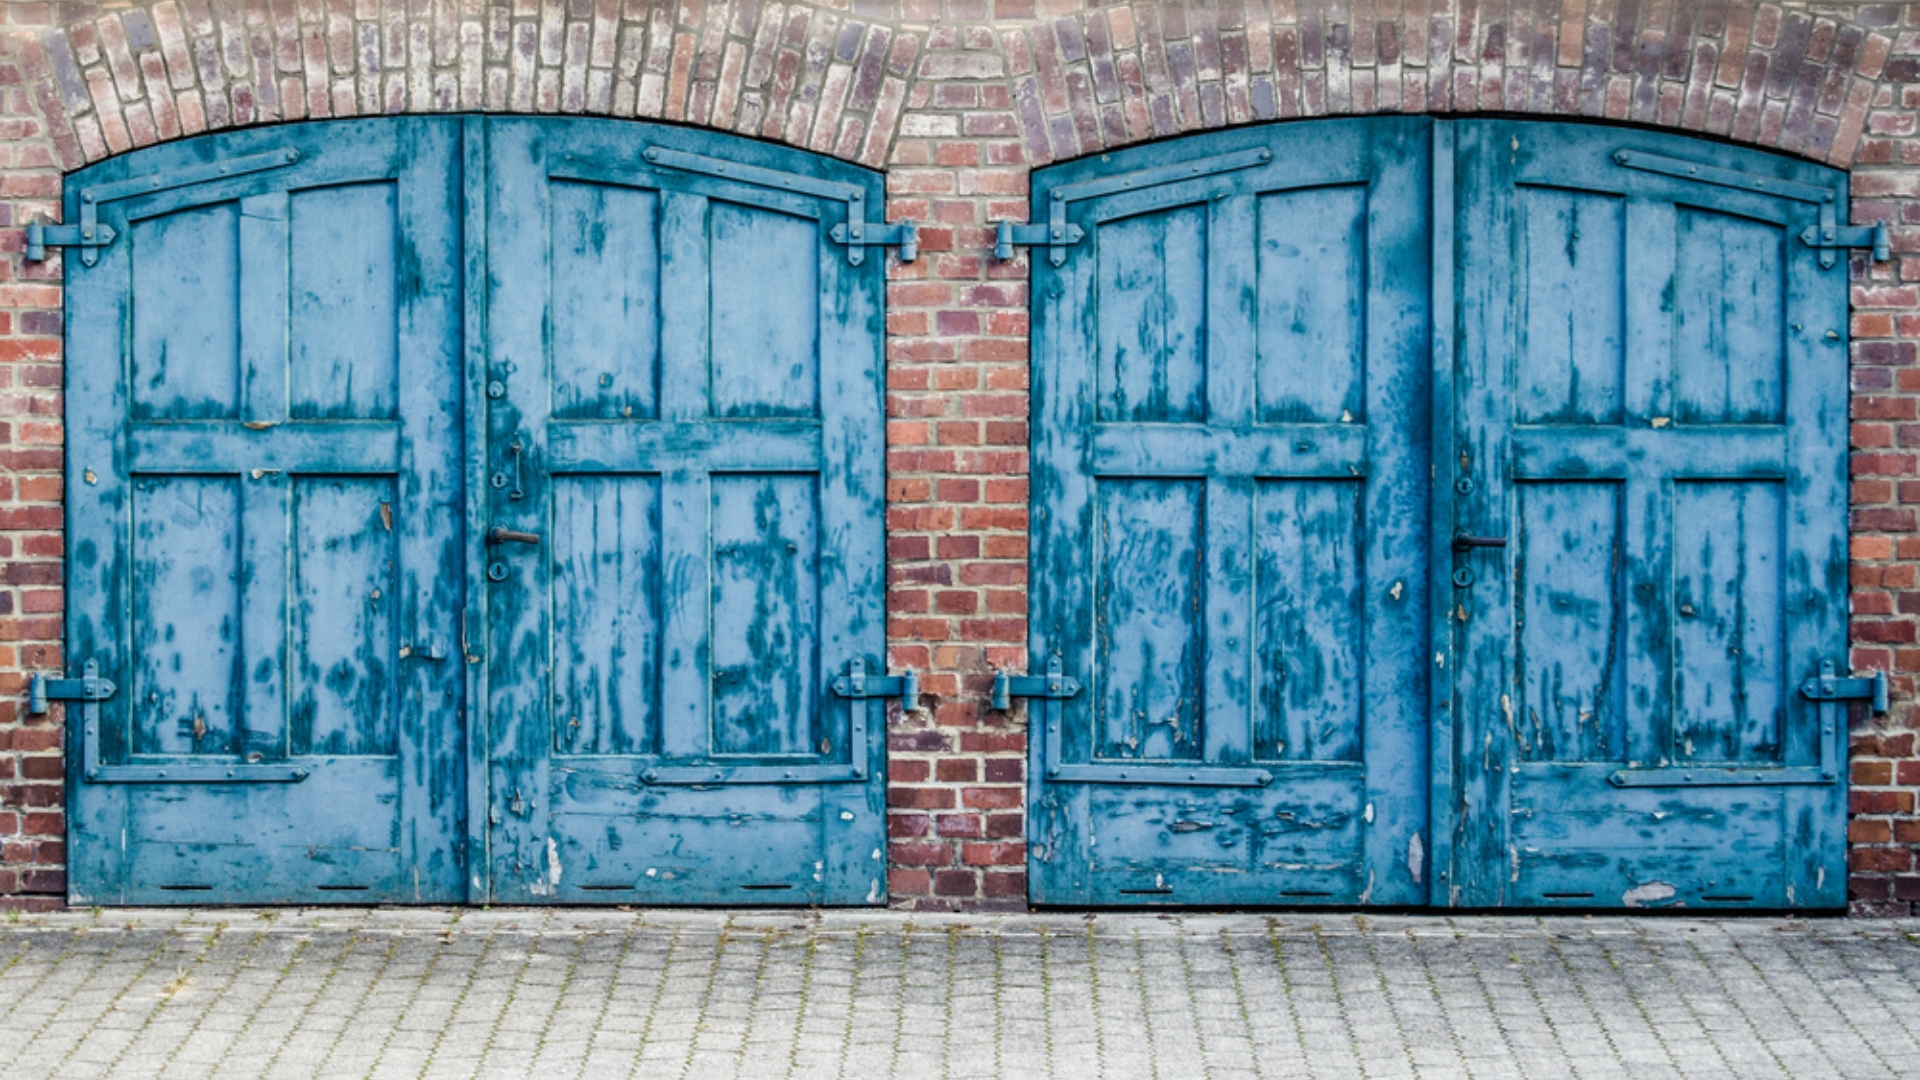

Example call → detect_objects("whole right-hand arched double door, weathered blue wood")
1029 117 1847 907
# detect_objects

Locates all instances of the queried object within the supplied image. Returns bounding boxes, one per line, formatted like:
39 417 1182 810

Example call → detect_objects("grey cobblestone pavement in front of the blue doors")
0 909 1920 1080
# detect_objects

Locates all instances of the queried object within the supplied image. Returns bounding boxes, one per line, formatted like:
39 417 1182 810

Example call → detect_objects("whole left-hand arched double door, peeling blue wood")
67 117 885 903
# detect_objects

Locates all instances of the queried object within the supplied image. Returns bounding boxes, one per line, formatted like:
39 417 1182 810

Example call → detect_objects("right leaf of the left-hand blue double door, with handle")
482 119 885 905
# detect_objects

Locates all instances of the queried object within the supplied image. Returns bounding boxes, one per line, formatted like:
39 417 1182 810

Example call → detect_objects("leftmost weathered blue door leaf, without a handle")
65 119 465 903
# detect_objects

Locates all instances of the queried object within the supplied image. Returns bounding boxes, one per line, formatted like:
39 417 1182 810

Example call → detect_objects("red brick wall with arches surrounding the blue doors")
0 0 1920 913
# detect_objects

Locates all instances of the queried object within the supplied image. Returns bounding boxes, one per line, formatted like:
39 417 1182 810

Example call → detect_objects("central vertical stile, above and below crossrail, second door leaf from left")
660 192 712 757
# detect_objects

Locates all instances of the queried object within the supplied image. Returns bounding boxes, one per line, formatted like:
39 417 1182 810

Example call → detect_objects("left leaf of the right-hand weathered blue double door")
1029 117 1430 905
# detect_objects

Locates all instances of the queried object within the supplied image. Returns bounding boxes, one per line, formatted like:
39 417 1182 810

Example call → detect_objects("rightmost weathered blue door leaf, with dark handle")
1436 121 1847 907
